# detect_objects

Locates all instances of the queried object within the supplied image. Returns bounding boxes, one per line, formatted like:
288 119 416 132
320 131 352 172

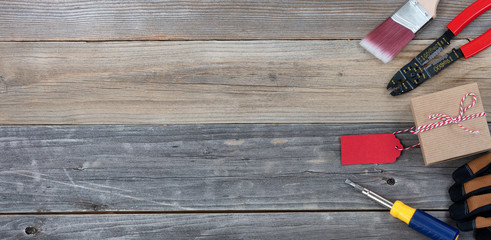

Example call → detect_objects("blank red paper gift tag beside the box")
341 133 403 165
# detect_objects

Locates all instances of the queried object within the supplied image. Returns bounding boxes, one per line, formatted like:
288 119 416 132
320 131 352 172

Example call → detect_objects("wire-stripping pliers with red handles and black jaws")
387 0 491 96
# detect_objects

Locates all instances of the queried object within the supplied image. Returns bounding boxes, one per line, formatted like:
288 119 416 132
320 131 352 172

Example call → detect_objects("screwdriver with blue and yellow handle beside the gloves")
344 179 459 240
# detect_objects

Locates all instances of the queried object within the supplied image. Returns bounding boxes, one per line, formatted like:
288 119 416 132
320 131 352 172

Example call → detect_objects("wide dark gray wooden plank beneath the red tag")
0 124 490 213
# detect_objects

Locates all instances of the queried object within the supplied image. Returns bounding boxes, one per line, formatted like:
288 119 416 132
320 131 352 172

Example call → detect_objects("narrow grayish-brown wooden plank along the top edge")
0 0 491 41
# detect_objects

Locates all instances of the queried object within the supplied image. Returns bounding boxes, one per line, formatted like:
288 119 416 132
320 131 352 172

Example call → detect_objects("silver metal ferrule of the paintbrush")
391 0 433 34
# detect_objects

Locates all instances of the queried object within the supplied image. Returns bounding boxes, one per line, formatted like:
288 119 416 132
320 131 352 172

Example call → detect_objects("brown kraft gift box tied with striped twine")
411 83 491 166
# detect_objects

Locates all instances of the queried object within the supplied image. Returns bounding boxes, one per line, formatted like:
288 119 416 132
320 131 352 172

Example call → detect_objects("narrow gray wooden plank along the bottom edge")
0 211 472 240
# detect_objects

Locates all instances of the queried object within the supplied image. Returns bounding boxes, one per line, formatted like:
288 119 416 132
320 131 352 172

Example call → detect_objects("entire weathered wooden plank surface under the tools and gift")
0 0 491 239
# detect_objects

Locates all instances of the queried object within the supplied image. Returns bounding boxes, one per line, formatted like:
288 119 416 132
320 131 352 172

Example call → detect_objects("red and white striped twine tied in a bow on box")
393 93 486 151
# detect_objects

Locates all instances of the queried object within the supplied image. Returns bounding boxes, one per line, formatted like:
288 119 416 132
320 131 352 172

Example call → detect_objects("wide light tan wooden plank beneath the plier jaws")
0 40 491 124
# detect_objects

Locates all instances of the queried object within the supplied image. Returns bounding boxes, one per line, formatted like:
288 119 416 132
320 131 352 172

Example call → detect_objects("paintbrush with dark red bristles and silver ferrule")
360 0 440 63
